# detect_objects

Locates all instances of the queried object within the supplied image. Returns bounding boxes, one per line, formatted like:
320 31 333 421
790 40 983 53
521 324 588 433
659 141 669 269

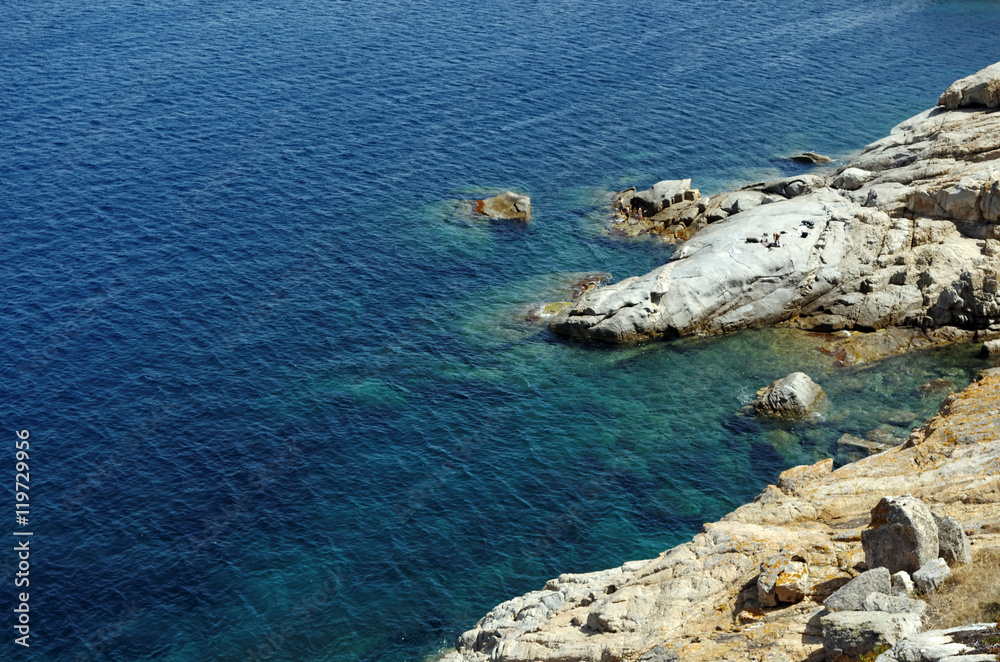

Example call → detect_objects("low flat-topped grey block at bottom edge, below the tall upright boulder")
820 611 920 662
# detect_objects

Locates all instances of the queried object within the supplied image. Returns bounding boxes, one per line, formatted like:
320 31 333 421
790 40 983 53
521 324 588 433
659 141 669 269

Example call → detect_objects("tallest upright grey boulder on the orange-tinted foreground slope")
861 495 938 574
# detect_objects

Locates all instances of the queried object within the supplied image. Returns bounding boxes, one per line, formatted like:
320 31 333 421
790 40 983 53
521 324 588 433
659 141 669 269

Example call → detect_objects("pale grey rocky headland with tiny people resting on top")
550 63 1000 343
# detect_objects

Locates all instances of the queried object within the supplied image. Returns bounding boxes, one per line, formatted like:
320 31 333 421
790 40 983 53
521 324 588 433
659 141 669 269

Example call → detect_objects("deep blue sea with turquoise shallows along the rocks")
0 0 1000 661
